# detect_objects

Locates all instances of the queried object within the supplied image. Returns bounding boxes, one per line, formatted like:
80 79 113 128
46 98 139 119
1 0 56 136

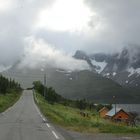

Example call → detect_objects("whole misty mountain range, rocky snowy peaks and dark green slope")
0 46 140 103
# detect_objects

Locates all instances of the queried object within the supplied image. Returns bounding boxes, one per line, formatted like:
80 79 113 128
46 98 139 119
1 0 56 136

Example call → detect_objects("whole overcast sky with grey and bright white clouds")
0 0 140 68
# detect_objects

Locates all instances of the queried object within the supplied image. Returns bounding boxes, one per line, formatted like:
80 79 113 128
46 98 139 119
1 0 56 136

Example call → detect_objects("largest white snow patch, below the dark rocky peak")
91 59 107 73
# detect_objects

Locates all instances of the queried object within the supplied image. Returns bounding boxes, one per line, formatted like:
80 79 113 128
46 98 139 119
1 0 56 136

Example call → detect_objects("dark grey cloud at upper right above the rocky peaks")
85 0 140 52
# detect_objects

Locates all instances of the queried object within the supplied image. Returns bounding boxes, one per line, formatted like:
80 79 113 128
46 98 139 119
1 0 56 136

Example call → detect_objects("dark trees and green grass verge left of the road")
0 75 21 113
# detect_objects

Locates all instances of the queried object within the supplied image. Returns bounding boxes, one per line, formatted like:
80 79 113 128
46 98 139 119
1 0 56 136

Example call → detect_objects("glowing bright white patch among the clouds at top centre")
34 0 95 33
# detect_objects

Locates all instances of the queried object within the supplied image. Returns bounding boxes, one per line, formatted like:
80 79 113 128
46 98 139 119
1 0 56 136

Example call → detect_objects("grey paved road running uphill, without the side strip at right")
0 91 64 140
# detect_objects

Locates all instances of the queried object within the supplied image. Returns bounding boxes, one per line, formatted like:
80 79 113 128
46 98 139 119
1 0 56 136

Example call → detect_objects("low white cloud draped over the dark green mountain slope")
19 37 89 71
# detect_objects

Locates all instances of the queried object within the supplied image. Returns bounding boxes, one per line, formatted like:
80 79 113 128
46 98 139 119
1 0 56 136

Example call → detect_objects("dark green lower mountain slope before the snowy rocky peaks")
3 60 140 103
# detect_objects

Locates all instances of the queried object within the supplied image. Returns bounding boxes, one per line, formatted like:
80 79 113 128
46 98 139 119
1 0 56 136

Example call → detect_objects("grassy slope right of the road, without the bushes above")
35 94 140 134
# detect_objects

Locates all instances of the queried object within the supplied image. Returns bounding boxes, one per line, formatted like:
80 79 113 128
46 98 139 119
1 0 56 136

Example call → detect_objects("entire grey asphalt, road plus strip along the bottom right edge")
0 91 140 140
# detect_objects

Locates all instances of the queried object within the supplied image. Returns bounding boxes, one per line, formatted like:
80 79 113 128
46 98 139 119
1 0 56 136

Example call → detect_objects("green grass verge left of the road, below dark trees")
0 91 21 113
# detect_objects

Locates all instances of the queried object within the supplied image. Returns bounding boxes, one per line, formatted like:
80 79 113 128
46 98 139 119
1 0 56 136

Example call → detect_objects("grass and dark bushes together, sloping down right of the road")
34 82 140 134
